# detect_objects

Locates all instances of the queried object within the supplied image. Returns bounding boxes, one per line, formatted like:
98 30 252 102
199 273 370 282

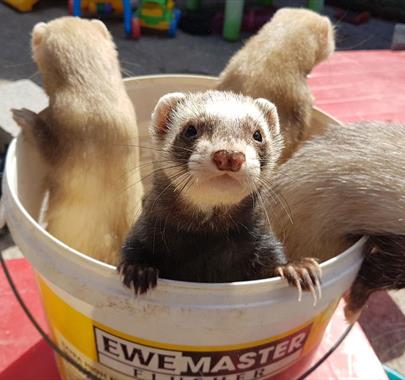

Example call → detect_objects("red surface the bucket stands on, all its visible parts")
0 50 405 380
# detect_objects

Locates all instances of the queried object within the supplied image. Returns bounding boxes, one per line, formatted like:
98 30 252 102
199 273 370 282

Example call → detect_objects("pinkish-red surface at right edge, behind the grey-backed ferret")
309 50 405 122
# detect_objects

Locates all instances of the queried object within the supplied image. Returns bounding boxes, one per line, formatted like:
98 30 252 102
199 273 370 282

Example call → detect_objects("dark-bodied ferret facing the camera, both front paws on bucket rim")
119 91 320 301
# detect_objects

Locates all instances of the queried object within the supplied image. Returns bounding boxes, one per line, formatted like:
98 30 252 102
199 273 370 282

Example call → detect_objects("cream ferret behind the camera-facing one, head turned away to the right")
216 8 335 162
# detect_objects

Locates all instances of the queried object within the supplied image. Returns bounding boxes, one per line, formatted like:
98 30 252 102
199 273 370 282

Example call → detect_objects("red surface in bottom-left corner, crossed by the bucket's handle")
0 259 59 380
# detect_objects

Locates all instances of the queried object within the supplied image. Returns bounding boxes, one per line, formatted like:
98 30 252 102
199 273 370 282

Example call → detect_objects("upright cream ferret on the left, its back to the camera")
14 17 142 264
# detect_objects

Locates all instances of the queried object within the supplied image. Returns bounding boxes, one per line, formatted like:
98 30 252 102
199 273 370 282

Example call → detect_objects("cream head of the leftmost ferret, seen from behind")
31 17 119 92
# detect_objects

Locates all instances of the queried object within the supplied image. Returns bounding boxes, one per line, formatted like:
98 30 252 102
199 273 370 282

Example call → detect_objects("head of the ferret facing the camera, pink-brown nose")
151 91 283 211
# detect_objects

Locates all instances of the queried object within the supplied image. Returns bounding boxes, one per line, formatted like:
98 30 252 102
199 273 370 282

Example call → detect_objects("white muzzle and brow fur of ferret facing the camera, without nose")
167 98 270 211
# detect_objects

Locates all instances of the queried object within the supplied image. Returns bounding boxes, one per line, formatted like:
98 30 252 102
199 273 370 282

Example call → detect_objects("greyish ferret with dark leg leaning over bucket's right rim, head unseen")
263 123 405 321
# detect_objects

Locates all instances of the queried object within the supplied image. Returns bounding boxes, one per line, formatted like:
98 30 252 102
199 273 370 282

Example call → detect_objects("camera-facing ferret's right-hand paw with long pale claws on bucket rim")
276 258 322 306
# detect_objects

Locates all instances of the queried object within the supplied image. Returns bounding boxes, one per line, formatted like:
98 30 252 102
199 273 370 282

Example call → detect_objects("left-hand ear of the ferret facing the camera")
152 92 186 135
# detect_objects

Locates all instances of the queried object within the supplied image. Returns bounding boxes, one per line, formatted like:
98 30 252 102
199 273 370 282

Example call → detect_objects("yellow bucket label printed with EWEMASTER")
39 278 337 380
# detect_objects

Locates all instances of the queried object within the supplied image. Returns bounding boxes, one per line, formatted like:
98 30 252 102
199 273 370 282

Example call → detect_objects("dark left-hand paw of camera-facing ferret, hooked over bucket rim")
117 261 159 295
